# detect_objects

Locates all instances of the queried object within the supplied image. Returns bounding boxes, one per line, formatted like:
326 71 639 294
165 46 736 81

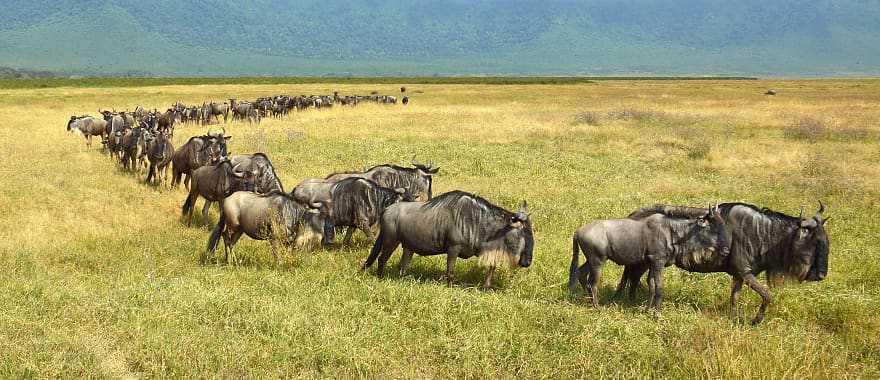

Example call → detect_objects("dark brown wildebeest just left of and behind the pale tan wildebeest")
183 159 253 226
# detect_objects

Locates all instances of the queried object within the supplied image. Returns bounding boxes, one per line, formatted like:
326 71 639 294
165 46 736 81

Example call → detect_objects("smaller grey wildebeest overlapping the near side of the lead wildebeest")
568 209 729 310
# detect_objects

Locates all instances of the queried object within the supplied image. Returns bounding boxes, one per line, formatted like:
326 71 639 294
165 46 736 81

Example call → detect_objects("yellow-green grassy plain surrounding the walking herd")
0 80 880 378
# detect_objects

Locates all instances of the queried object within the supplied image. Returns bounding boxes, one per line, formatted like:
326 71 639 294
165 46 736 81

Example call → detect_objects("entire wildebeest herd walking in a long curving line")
67 89 829 324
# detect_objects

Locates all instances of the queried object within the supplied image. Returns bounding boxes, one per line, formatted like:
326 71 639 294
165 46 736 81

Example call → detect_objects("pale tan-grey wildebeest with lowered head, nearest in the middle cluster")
206 191 327 263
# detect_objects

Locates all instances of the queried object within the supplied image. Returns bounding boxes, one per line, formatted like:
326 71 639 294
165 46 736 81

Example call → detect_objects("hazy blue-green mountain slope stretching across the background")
0 0 880 76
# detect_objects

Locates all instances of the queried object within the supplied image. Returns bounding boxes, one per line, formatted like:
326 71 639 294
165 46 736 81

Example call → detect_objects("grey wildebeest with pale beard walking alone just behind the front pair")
363 191 535 288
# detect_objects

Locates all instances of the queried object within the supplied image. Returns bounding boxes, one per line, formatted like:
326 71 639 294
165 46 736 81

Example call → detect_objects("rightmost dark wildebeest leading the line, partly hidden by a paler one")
621 202 830 324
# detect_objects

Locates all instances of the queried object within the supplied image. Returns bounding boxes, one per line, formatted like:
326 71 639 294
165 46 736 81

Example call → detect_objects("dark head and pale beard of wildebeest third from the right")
480 201 535 268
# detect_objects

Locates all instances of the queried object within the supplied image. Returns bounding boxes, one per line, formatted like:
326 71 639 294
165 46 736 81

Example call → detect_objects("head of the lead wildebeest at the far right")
788 201 830 281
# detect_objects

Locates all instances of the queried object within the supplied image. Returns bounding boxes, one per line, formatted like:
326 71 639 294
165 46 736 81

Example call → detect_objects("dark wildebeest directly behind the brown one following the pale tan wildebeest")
171 130 232 189
